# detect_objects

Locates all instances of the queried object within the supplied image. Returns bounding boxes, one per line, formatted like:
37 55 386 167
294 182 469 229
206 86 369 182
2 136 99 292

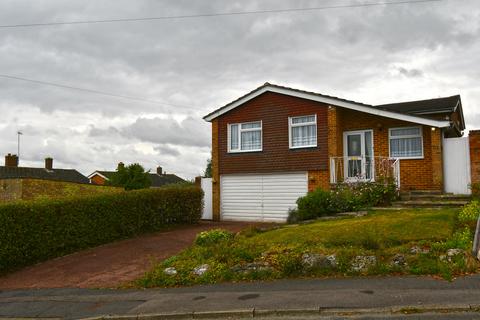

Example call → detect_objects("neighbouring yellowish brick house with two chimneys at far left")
0 154 97 202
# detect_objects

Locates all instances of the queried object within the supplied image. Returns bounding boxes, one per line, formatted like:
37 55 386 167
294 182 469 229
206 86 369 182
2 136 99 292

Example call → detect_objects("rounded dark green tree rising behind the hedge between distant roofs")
108 163 152 190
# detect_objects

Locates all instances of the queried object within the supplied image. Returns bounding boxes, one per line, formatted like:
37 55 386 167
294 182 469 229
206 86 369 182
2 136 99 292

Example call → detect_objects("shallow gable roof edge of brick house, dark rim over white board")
203 82 450 128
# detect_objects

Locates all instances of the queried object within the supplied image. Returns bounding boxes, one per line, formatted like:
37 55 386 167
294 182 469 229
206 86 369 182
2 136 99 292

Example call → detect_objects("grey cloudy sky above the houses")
0 0 480 178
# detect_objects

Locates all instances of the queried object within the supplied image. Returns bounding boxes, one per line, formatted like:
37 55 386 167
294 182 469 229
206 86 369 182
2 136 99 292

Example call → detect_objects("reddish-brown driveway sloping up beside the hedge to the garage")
0 222 258 290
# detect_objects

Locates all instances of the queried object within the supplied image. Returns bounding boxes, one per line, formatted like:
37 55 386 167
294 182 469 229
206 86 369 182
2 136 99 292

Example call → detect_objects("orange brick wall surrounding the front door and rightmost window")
336 108 443 190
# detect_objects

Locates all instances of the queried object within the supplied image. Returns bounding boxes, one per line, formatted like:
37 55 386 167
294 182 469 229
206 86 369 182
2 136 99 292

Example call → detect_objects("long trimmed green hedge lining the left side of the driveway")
0 187 203 273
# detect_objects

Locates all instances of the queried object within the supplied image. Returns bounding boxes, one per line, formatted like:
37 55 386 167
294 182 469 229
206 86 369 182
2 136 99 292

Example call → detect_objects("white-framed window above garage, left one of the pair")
228 121 262 152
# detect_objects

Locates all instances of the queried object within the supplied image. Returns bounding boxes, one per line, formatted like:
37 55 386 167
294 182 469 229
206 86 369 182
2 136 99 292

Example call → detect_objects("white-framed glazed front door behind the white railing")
343 130 374 181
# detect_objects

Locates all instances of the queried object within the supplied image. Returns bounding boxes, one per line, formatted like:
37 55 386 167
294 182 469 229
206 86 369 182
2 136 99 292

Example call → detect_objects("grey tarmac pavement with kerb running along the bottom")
0 275 480 320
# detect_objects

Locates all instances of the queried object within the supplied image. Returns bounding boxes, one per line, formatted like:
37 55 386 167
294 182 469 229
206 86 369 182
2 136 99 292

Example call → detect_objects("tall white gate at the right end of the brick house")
443 137 471 194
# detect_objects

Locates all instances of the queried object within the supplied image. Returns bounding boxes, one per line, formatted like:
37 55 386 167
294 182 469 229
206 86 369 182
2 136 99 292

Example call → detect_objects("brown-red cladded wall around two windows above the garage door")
218 92 328 175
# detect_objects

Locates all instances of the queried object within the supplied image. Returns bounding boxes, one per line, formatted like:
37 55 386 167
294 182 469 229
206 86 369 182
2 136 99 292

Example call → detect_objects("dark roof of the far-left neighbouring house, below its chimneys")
0 166 90 183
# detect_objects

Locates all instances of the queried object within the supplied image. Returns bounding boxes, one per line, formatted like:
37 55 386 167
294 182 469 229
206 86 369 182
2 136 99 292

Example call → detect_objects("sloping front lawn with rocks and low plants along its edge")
135 209 478 287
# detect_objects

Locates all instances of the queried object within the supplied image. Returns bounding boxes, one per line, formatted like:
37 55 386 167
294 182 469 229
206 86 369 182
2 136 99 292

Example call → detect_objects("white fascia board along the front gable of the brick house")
205 86 450 128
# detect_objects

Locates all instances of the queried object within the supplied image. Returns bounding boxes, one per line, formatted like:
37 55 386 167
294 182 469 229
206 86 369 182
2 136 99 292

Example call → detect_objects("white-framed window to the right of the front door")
389 127 423 159
